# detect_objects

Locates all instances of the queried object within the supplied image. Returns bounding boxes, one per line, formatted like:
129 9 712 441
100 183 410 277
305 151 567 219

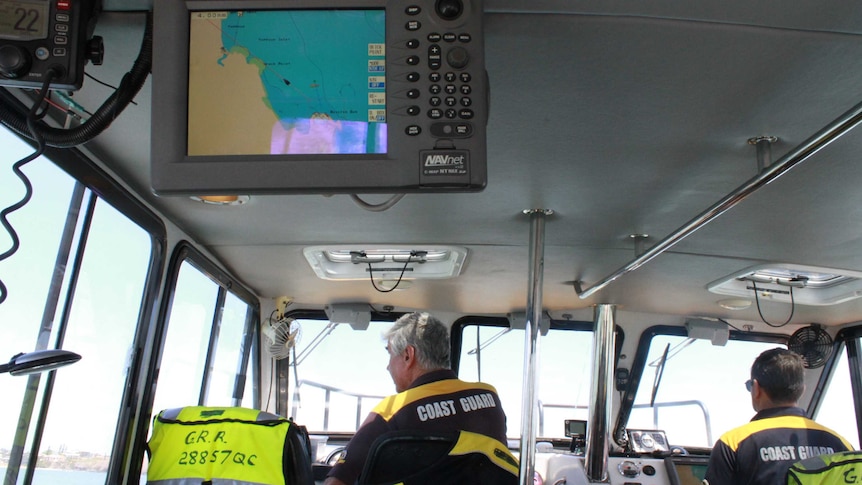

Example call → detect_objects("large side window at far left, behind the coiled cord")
0 127 155 484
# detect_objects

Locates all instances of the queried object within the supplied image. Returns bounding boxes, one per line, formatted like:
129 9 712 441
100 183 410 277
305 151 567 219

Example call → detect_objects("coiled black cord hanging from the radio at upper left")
0 69 56 303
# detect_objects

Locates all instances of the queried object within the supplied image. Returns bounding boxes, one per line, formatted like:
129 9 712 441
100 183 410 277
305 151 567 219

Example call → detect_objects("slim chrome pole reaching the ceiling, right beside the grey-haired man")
520 209 554 485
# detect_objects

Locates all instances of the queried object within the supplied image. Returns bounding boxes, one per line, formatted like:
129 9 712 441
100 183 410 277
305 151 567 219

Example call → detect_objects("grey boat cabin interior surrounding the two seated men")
0 0 862 485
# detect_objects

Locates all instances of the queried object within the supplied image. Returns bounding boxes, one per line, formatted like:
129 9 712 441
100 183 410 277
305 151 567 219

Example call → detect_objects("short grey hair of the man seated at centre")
383 312 450 370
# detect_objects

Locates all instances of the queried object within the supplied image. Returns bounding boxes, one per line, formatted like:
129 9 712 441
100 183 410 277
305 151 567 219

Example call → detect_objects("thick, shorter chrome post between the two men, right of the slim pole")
585 304 616 482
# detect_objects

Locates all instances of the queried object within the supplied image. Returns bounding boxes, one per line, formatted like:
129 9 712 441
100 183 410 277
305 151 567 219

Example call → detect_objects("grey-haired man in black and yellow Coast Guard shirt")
325 313 508 485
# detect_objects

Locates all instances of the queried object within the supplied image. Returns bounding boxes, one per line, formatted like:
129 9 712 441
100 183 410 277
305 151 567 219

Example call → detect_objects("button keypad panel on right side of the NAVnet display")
386 0 488 188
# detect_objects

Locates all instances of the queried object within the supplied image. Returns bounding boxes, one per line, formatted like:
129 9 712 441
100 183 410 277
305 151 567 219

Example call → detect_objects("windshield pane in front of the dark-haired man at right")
627 335 781 448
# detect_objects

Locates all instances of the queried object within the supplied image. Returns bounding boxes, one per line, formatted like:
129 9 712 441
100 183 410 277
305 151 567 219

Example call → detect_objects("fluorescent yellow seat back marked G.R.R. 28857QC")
147 406 314 485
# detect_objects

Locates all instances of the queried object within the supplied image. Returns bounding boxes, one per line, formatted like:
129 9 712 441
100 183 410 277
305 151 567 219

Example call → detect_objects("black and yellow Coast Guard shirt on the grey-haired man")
329 369 506 484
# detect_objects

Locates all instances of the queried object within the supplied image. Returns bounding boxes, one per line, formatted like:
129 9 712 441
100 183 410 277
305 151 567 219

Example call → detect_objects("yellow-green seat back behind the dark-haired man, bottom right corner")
787 451 862 485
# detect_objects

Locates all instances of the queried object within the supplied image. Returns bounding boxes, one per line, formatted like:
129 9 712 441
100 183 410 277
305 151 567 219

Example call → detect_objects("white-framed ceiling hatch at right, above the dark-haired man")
707 263 862 309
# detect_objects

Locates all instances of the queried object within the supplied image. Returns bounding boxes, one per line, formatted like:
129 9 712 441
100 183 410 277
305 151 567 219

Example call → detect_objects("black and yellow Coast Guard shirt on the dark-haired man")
705 407 852 485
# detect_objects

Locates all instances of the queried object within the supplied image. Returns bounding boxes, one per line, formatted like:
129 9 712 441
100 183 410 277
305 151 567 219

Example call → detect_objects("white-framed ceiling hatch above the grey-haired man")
302 245 467 281
